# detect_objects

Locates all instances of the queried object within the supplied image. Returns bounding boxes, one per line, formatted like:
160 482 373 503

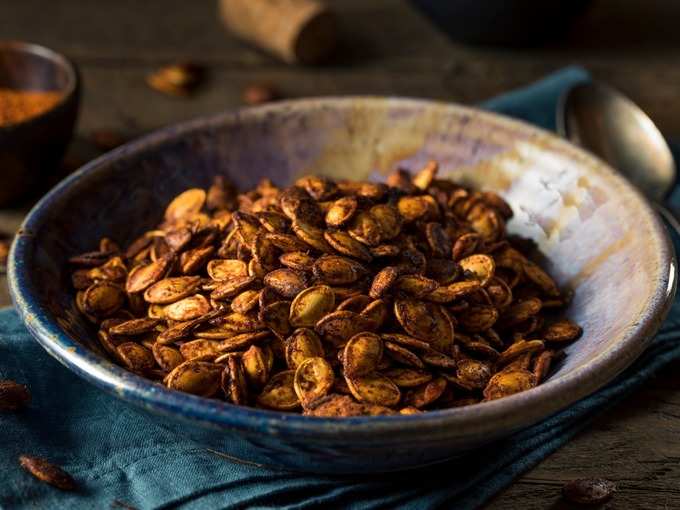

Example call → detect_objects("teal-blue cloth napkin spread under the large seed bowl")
0 68 680 510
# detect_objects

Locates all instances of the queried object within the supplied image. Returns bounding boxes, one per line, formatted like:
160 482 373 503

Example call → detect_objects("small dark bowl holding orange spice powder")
0 41 80 206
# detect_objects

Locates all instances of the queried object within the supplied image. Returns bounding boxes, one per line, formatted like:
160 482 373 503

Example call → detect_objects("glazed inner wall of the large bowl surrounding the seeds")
11 98 674 438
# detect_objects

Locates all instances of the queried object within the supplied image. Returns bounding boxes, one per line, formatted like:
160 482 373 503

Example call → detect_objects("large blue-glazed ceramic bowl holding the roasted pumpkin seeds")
9 98 676 473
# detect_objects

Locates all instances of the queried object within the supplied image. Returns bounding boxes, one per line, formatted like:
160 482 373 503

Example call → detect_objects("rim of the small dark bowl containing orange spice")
0 40 80 133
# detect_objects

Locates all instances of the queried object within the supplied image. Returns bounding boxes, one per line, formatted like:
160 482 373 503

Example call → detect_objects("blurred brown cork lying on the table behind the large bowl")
219 0 337 64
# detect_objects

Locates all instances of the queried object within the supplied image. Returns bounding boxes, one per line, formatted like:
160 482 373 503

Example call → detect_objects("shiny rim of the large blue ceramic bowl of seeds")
7 96 677 440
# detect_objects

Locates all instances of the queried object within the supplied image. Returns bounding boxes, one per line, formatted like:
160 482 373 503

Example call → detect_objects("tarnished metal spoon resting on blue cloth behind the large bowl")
557 82 680 234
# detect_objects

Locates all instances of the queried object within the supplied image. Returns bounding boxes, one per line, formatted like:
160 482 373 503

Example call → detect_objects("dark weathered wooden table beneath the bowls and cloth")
0 0 680 510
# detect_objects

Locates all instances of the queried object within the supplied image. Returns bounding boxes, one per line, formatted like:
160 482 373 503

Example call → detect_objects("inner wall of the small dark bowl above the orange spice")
0 42 75 94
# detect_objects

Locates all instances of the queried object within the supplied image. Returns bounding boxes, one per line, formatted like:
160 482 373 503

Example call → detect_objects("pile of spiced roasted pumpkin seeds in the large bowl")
70 162 581 416
